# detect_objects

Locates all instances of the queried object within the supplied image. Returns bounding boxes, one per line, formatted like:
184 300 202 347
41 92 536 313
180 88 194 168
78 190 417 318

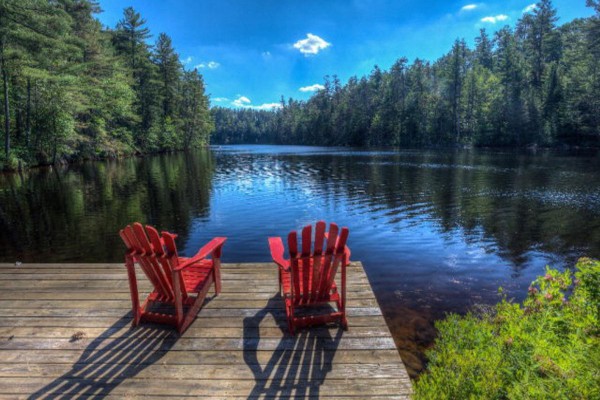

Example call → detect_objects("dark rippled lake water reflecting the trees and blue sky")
0 146 600 372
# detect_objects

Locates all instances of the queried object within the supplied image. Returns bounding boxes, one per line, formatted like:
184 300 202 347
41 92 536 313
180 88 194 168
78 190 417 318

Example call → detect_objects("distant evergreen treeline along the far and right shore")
211 0 600 147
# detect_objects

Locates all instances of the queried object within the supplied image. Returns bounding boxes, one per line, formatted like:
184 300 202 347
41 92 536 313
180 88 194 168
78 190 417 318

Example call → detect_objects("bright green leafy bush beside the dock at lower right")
415 258 600 400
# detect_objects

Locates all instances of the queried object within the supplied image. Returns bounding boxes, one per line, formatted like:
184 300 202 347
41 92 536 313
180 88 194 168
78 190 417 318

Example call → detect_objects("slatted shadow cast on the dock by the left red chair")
28 313 179 399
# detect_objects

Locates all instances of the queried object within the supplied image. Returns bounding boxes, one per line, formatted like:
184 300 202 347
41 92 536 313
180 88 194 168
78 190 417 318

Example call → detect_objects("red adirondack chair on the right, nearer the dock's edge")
269 221 350 334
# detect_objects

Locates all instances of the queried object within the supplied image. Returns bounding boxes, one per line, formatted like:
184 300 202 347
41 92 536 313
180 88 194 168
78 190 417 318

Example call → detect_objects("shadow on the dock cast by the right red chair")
244 294 343 399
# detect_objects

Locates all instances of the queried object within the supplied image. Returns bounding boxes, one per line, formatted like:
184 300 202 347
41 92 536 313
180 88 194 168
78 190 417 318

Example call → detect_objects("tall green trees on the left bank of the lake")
0 0 213 169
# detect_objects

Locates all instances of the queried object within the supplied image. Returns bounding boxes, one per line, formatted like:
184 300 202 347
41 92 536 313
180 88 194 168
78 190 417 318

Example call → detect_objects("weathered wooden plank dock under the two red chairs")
0 262 412 399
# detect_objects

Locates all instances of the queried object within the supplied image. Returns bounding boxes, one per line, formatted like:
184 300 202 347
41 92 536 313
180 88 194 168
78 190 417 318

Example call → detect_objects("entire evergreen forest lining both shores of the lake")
0 0 600 170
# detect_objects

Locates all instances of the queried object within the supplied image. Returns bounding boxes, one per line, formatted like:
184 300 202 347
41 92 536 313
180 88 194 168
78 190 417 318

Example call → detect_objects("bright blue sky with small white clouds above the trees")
98 0 592 108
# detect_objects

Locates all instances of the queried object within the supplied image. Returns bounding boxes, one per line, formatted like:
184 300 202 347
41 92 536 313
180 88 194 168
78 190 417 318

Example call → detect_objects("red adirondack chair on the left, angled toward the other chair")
119 222 227 333
